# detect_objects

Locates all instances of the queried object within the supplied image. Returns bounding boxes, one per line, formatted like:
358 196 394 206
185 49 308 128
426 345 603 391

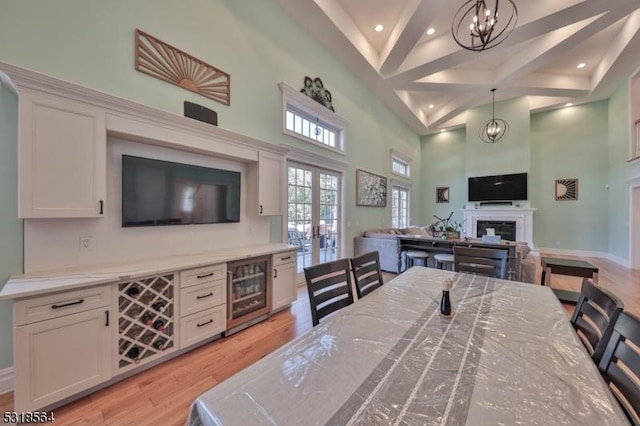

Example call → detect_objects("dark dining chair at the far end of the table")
453 246 509 279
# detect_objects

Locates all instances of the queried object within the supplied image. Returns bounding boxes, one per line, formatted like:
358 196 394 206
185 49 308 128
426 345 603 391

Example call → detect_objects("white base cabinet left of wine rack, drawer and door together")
14 286 112 411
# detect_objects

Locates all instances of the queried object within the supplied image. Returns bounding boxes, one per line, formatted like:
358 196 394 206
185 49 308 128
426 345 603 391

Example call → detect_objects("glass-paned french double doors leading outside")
287 162 342 282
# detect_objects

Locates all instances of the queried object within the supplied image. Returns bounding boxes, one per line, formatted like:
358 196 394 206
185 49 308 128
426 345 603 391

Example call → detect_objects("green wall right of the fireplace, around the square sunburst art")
529 101 608 252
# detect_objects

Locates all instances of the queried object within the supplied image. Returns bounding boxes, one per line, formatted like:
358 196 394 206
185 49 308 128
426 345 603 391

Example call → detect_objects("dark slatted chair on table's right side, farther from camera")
571 279 624 364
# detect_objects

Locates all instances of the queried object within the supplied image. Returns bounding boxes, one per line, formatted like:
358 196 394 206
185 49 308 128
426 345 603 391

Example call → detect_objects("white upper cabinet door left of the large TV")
19 90 106 218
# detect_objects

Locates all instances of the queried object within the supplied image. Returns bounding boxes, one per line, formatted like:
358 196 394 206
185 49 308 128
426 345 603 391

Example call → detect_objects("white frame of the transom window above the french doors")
278 82 349 155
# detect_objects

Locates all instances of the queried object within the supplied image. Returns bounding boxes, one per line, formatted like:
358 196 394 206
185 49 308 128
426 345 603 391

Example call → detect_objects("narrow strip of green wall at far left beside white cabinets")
0 84 22 370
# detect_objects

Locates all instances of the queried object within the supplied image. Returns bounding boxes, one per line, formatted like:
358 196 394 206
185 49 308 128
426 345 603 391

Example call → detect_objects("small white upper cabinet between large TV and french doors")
247 151 285 216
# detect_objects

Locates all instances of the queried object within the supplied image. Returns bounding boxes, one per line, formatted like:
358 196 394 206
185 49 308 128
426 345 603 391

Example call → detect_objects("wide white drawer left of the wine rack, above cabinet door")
13 285 111 326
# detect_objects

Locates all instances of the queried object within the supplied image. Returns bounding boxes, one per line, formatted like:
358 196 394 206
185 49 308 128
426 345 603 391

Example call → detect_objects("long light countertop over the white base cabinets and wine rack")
0 244 297 300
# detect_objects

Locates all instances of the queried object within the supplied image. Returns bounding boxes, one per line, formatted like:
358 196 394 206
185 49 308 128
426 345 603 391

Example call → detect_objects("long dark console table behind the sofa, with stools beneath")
398 235 516 280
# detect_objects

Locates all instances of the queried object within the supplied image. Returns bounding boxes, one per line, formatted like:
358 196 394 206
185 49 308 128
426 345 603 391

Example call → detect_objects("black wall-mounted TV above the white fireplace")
469 173 527 201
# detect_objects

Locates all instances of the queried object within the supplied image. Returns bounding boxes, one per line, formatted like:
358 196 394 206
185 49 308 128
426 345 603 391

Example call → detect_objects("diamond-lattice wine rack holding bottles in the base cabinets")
118 274 175 369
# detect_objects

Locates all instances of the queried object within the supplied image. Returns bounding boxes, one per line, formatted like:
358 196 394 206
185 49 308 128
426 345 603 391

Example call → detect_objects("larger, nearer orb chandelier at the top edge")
451 0 518 52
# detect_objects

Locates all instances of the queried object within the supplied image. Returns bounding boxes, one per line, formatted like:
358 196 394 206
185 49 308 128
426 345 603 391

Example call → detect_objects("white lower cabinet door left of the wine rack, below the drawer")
15 308 111 411
